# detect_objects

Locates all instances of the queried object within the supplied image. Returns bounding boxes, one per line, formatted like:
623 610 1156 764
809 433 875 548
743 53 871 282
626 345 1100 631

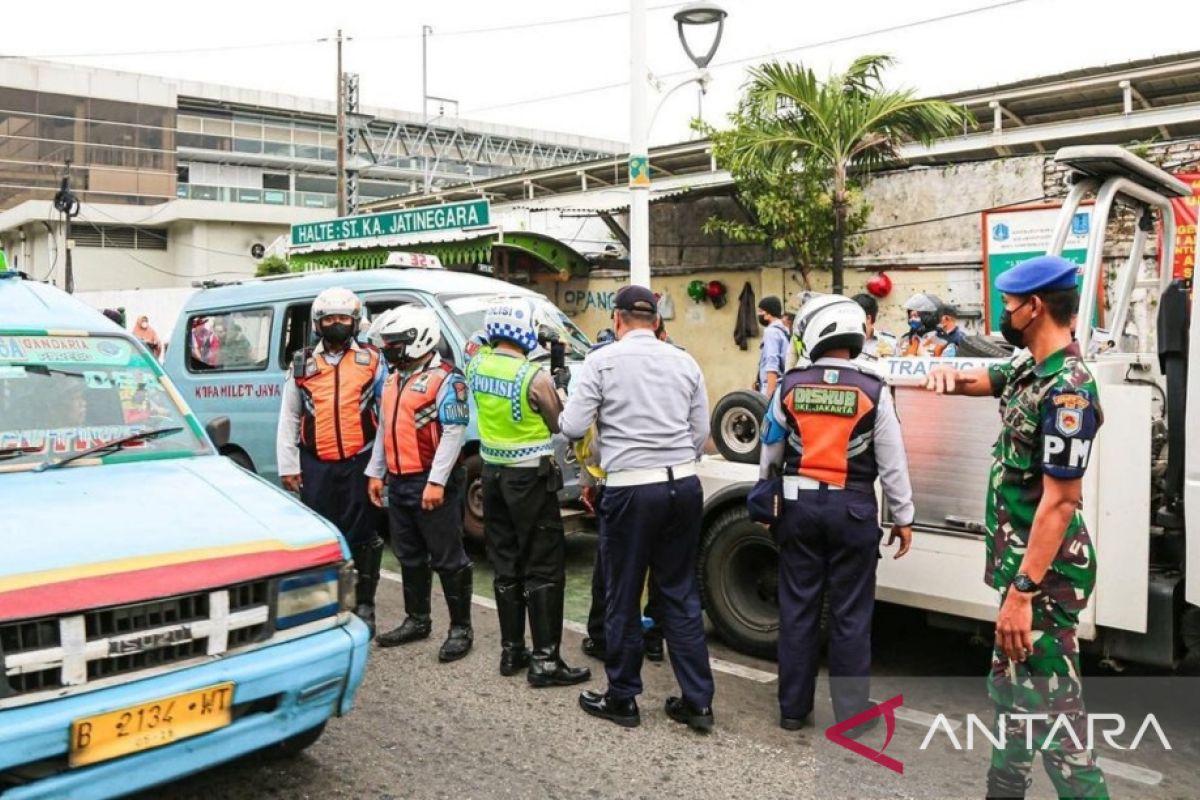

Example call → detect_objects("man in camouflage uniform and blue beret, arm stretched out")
928 255 1108 798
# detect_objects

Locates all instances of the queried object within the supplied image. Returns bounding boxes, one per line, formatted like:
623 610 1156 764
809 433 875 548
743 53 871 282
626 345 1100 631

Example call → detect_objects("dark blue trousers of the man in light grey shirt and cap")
600 476 713 708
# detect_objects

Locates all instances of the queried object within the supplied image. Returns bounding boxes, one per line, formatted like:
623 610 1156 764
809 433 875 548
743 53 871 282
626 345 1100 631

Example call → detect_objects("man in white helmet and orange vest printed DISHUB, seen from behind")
760 295 913 736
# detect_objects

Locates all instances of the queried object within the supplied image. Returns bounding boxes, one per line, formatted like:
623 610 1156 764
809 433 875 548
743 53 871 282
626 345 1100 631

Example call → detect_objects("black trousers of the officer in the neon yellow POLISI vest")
481 464 566 587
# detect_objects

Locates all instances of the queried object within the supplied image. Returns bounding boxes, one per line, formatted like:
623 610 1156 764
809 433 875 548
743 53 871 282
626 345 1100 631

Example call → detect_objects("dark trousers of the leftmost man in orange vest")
300 449 379 547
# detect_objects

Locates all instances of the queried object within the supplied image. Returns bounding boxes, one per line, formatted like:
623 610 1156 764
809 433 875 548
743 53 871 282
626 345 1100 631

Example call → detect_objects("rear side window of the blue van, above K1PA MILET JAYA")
187 308 274 372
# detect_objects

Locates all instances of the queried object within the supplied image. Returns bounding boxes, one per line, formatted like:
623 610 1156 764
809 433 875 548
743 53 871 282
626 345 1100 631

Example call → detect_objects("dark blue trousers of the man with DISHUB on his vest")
775 489 881 722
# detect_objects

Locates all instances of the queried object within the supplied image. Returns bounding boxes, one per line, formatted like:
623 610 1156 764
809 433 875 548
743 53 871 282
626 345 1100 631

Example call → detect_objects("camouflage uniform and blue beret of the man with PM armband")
984 257 1108 798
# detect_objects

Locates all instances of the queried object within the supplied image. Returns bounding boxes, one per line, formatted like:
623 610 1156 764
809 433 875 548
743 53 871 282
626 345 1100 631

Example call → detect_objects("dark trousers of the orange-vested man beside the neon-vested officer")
388 473 470 573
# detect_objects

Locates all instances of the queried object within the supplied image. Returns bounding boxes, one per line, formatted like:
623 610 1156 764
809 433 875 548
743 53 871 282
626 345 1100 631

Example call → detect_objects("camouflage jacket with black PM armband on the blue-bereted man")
984 342 1104 610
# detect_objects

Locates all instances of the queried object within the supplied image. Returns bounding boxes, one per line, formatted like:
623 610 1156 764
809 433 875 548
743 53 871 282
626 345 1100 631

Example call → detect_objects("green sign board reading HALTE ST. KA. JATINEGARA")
292 200 491 247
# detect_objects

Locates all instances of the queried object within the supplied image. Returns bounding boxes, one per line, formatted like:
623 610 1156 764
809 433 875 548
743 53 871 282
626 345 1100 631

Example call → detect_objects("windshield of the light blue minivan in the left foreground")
0 335 209 470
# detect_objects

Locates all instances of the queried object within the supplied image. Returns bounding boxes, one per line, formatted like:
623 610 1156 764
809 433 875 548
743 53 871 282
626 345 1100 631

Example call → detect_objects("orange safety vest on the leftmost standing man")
294 347 379 461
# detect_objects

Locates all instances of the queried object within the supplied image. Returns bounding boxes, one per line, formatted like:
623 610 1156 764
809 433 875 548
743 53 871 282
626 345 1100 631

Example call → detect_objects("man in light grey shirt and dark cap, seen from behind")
559 285 713 730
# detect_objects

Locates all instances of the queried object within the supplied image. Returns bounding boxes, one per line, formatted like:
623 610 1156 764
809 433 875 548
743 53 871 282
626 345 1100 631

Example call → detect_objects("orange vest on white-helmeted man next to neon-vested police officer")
382 361 453 475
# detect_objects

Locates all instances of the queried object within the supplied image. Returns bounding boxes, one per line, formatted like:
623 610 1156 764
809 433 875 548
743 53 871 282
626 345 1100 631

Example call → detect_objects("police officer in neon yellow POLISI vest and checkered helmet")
467 297 592 687
